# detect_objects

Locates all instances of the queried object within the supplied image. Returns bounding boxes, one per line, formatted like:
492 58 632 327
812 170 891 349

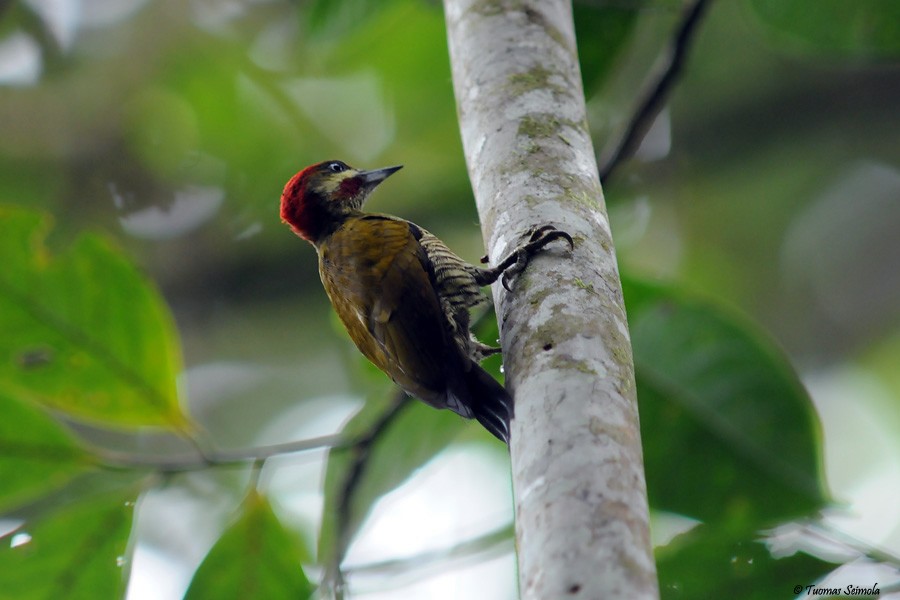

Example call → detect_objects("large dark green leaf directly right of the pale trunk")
623 278 826 531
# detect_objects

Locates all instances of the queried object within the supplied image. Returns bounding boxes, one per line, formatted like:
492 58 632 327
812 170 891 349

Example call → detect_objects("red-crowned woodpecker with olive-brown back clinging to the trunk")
281 160 573 444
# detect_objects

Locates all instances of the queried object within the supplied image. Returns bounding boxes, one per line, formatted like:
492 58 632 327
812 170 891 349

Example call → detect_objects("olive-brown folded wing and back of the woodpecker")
320 214 472 417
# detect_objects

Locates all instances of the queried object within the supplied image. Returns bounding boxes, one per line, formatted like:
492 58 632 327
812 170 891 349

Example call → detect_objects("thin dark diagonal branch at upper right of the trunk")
599 0 711 184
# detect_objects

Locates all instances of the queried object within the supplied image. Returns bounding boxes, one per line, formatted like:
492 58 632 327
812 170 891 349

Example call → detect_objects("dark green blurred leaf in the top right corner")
749 0 900 60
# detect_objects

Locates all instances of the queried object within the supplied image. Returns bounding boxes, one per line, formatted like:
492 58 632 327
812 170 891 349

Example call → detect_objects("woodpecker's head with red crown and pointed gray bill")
281 160 400 244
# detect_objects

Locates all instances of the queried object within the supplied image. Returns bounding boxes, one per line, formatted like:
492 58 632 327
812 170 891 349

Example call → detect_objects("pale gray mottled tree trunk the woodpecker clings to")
444 0 658 600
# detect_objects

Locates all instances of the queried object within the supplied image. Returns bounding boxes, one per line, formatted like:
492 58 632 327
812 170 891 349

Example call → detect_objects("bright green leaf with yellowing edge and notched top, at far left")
0 207 187 428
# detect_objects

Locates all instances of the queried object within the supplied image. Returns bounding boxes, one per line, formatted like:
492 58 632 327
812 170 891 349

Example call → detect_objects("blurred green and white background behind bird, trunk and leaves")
0 0 900 600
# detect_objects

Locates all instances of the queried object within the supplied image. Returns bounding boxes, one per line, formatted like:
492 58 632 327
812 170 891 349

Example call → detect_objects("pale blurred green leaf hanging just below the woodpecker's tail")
319 390 469 569
